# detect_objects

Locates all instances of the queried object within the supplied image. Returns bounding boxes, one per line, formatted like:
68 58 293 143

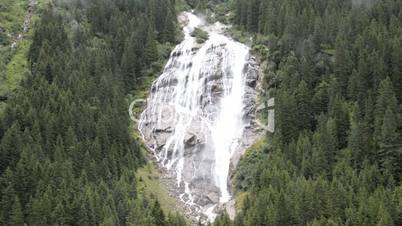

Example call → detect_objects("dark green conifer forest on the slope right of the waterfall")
215 0 402 226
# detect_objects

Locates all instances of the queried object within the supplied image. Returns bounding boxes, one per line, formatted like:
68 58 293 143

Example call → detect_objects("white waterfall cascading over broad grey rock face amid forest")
139 12 257 219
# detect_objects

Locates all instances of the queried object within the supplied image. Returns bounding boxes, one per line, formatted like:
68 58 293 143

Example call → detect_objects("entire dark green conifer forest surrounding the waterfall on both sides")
0 0 402 226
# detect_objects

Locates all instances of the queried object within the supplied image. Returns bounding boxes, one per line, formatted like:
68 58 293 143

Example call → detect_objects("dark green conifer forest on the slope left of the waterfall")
0 0 185 226
